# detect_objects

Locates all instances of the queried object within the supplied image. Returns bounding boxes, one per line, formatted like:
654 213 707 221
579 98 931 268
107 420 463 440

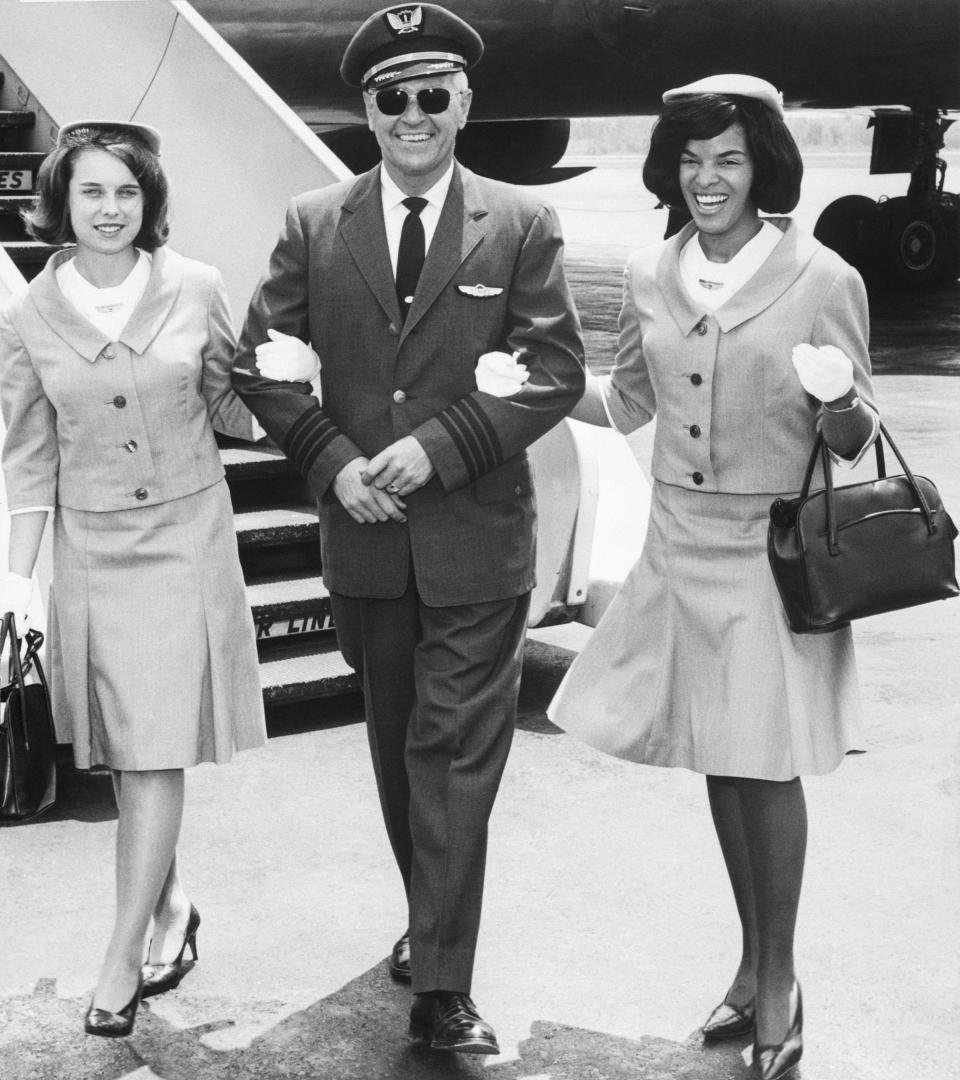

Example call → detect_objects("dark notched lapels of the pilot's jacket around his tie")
340 162 488 341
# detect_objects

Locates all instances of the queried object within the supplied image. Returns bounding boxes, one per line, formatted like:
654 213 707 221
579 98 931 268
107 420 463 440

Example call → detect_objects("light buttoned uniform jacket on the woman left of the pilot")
0 247 253 511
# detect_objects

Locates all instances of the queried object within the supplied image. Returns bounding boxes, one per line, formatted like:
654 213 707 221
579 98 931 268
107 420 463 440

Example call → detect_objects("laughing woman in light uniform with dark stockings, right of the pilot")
550 75 878 1080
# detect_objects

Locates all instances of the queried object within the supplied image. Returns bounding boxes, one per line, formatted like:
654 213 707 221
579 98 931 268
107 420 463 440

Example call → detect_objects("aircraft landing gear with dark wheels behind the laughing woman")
813 110 960 287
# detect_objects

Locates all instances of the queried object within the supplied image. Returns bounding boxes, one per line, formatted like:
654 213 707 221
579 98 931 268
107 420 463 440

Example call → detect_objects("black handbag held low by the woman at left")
0 611 56 822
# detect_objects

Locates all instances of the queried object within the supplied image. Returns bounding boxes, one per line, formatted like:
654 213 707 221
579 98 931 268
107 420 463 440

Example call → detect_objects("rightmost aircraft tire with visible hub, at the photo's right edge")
883 197 957 287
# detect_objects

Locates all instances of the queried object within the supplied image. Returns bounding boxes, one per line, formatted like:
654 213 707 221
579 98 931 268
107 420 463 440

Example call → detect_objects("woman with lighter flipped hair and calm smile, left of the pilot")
0 121 266 1037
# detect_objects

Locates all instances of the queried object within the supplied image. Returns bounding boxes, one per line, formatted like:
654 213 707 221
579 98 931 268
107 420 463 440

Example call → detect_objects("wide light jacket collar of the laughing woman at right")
657 218 820 336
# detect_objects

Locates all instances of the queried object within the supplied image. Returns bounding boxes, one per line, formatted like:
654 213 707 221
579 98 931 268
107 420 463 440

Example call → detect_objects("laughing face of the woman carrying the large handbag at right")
679 123 758 250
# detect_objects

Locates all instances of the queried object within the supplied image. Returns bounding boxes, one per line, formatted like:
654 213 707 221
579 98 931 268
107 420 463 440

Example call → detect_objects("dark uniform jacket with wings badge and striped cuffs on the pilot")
233 165 584 605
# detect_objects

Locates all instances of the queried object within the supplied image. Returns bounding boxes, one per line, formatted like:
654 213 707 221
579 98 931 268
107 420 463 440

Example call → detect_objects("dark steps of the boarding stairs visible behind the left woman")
0 67 356 706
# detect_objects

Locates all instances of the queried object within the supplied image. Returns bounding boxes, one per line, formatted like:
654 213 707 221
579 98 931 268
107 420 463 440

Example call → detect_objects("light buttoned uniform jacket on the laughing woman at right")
607 221 873 494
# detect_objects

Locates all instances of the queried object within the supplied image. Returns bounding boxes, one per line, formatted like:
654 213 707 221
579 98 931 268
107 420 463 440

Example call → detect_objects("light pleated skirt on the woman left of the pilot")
49 481 266 771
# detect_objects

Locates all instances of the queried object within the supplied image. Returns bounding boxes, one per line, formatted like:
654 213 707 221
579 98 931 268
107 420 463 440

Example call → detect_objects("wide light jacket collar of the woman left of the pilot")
27 247 184 364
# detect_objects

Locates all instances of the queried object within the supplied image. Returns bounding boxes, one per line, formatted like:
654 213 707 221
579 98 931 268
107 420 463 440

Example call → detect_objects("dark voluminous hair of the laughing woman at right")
644 94 803 214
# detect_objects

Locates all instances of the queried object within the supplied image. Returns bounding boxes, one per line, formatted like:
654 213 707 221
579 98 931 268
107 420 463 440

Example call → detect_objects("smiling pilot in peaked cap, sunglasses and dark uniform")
234 3 583 1054
